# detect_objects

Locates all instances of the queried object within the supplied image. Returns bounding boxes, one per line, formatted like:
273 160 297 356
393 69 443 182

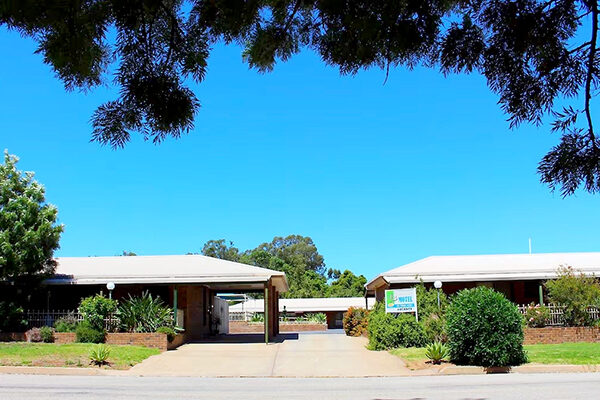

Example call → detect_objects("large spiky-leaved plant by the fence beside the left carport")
117 292 173 332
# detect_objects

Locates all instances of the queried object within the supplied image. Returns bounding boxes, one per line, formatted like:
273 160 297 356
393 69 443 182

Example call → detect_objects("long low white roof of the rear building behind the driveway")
229 297 375 312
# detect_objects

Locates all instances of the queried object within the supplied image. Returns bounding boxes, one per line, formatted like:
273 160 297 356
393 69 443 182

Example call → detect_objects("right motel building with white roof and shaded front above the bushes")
365 253 600 304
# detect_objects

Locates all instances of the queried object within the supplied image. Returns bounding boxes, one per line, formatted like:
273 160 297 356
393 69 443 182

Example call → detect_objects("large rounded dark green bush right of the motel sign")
446 286 527 367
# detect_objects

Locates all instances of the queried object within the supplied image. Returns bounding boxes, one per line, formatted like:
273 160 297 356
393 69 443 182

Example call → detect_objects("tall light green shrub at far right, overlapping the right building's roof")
546 267 600 326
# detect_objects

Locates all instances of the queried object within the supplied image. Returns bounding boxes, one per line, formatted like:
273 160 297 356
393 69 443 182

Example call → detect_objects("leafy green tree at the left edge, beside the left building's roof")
0 151 63 283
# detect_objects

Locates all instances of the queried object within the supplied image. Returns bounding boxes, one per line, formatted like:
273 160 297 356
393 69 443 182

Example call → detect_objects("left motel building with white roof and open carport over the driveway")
44 255 288 342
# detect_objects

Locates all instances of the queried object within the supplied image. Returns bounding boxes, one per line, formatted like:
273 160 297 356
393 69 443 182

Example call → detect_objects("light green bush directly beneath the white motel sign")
367 302 427 350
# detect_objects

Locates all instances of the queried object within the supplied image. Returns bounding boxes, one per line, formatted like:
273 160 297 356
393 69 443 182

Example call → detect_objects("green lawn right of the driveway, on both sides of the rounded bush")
390 343 600 367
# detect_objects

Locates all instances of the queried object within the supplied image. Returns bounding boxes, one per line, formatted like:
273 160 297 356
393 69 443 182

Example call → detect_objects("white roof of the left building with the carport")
46 255 288 292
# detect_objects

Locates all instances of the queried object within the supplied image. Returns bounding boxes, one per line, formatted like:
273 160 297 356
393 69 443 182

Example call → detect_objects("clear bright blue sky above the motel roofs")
0 30 600 278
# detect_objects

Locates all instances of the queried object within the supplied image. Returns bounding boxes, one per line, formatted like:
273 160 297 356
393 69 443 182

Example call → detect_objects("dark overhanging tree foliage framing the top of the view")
0 0 600 195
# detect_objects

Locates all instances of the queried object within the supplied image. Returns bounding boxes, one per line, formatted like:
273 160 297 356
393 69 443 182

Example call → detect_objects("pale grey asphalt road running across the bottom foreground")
0 373 600 400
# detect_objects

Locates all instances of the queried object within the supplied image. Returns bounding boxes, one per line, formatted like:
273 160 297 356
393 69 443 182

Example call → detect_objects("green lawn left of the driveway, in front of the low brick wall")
0 342 160 369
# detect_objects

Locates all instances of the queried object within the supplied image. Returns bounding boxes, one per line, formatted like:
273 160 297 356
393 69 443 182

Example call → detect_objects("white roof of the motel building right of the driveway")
366 253 600 290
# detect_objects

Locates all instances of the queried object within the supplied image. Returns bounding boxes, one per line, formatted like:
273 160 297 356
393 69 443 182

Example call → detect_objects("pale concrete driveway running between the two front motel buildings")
127 333 410 377
